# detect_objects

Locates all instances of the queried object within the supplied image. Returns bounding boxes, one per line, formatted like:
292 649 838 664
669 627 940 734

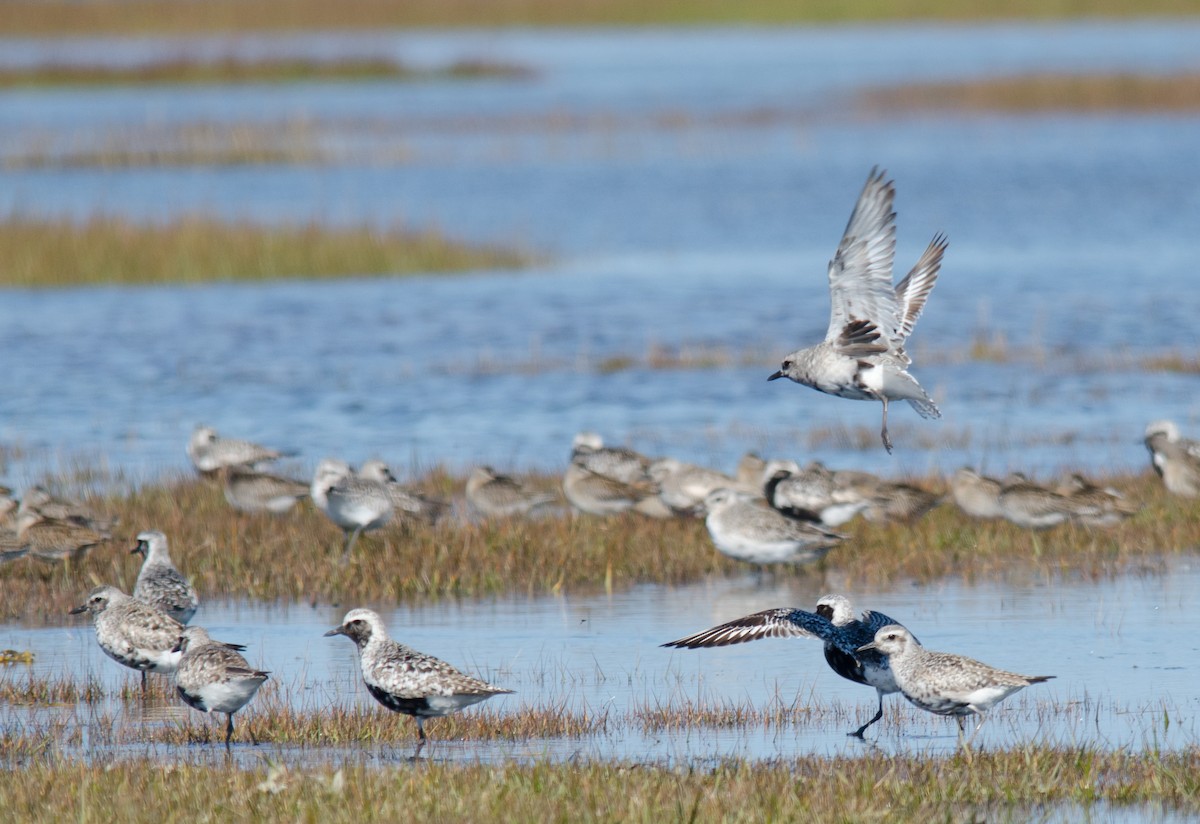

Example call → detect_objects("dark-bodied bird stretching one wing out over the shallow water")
662 595 900 738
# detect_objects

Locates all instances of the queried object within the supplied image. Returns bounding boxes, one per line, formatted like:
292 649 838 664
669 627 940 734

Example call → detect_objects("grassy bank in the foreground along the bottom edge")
0 747 1200 824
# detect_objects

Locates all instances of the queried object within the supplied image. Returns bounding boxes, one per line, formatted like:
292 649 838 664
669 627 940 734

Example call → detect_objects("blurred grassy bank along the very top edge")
0 0 1196 37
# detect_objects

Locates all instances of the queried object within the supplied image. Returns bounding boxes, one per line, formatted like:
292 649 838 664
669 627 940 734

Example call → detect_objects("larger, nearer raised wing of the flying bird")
826 167 902 343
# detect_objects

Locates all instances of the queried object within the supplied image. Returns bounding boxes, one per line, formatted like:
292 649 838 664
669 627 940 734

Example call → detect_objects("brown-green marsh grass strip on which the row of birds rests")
0 471 1200 622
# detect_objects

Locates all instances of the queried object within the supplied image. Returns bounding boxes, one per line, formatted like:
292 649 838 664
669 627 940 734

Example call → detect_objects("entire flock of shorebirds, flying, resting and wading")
0 170 1200 752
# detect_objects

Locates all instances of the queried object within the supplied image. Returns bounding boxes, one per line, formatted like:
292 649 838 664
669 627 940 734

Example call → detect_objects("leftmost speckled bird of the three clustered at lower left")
71 587 184 692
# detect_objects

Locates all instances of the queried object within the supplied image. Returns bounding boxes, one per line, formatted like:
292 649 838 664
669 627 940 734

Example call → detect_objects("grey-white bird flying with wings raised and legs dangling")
767 168 947 452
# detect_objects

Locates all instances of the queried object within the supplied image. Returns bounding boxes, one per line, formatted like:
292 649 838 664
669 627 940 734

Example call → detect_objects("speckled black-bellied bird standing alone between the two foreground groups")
325 609 512 753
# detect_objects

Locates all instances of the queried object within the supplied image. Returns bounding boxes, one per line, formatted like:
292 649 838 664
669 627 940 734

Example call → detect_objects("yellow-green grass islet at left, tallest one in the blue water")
0 217 529 288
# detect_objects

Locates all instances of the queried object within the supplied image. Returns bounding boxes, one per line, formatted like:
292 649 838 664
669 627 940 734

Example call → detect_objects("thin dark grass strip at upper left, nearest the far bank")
0 56 533 89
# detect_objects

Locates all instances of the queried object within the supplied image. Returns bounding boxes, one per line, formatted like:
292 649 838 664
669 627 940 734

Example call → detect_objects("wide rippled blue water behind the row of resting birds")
0 22 1200 488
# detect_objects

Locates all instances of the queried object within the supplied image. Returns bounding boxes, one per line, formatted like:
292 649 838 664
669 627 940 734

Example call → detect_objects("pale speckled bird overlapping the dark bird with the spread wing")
859 624 1054 739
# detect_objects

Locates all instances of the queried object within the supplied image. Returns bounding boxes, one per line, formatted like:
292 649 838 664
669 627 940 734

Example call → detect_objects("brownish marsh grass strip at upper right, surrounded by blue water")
859 74 1200 113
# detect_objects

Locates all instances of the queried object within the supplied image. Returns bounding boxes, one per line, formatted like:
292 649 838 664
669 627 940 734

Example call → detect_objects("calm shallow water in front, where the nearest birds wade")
0 561 1200 765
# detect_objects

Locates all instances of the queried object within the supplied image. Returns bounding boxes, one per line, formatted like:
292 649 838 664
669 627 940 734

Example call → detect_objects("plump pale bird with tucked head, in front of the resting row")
704 489 844 564
